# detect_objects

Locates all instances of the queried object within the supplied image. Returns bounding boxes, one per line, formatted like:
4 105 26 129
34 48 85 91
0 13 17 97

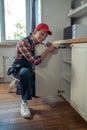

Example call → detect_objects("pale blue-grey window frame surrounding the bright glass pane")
0 0 31 44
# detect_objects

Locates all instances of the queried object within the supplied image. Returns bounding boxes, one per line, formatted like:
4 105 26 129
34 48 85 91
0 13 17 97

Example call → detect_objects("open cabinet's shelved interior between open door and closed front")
58 46 71 102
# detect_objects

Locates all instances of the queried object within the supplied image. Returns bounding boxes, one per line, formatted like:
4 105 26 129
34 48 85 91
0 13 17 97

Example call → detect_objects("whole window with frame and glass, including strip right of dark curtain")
0 0 40 42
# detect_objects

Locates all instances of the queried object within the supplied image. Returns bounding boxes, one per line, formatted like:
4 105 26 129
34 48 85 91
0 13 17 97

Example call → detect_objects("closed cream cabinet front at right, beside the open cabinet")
71 43 87 121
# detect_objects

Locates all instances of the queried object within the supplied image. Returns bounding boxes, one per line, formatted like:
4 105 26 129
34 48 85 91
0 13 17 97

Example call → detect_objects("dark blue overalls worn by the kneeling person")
8 37 35 100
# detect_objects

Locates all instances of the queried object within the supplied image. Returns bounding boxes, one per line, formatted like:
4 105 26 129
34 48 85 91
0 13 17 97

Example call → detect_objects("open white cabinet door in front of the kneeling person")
35 45 60 96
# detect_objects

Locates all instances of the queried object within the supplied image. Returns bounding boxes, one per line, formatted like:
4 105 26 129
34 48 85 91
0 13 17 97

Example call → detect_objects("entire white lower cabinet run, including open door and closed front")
35 40 87 121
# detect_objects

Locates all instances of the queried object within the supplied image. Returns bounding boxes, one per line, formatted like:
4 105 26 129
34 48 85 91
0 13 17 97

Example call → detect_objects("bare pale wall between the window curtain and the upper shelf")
41 0 71 41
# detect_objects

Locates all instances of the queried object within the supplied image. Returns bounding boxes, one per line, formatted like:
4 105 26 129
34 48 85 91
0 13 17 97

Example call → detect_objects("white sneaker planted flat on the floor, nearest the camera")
21 103 31 118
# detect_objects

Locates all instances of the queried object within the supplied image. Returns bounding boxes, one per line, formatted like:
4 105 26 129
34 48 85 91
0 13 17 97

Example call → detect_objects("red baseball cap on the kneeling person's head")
35 23 52 35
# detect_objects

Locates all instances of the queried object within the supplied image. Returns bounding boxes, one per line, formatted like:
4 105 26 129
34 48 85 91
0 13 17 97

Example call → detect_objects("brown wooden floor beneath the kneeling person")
0 84 87 130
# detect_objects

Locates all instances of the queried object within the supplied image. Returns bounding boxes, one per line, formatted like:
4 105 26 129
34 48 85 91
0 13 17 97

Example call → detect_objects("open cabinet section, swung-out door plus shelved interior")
35 44 71 99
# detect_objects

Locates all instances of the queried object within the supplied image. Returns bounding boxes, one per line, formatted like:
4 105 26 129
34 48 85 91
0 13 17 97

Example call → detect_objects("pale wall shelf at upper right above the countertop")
68 3 87 17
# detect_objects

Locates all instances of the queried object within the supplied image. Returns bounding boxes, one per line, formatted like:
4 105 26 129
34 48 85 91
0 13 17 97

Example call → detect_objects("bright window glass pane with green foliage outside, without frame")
4 0 26 40
